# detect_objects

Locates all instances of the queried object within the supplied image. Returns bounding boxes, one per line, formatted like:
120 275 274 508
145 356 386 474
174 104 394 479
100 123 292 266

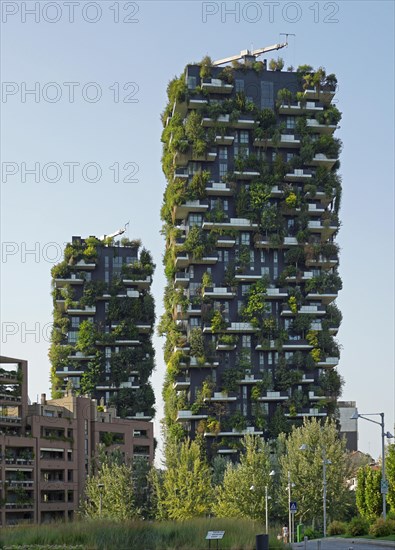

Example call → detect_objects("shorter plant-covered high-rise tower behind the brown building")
49 237 155 419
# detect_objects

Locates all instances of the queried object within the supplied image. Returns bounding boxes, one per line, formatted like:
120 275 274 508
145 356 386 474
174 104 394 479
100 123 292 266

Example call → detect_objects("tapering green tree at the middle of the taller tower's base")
213 435 271 520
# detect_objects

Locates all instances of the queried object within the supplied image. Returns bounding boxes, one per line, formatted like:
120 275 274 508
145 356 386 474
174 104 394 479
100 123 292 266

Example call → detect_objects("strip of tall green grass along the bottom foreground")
0 518 284 550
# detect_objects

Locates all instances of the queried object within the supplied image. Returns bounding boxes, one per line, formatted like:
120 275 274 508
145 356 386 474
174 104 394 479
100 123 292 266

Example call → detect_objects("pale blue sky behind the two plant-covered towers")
1 1 395 466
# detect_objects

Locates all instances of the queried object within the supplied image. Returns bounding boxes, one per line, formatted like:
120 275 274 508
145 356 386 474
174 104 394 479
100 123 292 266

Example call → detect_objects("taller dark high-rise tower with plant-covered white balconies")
160 58 342 456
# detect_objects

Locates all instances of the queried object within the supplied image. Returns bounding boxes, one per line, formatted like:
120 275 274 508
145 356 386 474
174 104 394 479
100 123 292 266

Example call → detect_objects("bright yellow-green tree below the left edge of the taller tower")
154 439 212 520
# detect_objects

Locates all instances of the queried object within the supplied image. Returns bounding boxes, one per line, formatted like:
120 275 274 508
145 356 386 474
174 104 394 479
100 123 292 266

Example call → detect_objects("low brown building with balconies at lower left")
0 357 154 525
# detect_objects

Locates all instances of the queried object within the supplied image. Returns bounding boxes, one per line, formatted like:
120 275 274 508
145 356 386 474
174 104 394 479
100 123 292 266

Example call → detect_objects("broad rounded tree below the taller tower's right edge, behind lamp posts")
278 419 348 526
